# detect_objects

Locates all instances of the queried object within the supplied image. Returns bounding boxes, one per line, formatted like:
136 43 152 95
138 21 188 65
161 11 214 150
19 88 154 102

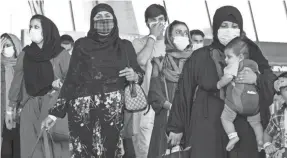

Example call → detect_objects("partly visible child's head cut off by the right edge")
274 72 287 102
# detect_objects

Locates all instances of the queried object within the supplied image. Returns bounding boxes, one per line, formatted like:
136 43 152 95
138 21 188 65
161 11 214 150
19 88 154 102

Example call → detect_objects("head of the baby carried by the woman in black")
224 37 249 65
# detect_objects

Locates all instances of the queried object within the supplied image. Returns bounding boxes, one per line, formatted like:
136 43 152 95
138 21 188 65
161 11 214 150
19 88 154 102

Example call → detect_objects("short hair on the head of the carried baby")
225 37 249 59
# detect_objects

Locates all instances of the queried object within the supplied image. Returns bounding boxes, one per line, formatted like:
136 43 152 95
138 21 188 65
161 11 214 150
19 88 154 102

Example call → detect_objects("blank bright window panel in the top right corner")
251 0 287 42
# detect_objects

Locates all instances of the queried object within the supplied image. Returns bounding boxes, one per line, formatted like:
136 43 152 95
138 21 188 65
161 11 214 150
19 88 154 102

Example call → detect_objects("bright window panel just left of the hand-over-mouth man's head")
132 0 163 35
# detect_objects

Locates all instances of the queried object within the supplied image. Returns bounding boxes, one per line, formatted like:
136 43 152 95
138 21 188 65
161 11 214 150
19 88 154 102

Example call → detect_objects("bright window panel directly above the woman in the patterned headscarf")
165 0 211 38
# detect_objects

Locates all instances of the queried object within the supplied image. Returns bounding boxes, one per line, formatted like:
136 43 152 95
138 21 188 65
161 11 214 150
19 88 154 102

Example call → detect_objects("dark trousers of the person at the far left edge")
1 123 21 158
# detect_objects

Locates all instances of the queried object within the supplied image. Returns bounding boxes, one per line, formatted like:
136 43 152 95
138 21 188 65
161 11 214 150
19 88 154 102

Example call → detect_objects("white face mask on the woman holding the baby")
217 28 240 46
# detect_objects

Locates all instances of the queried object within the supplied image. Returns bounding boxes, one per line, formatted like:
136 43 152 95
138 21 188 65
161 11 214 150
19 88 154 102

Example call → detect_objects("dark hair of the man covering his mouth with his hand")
144 4 167 22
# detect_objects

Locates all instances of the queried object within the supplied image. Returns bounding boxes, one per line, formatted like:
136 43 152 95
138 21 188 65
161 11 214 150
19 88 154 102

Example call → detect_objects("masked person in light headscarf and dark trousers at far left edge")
0 33 22 158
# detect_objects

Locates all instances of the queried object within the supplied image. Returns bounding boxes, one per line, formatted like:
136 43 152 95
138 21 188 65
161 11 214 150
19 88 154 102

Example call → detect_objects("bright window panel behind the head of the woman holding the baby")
207 0 256 40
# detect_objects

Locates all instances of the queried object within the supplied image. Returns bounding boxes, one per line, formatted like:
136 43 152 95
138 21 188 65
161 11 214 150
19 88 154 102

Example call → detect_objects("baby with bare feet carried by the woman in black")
217 37 263 151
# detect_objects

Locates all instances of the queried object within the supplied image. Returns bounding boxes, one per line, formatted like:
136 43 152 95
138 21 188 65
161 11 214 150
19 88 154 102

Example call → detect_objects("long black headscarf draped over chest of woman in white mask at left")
23 15 63 96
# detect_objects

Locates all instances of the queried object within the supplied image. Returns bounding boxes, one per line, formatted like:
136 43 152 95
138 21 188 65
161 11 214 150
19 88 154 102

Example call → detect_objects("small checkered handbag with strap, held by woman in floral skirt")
124 42 150 115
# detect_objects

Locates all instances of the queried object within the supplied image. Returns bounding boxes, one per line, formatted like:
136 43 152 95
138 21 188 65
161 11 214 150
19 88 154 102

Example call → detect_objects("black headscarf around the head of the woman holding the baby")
212 6 243 51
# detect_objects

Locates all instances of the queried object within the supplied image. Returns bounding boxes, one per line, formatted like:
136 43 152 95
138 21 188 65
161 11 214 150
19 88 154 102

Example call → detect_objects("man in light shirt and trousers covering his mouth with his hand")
122 4 167 158
